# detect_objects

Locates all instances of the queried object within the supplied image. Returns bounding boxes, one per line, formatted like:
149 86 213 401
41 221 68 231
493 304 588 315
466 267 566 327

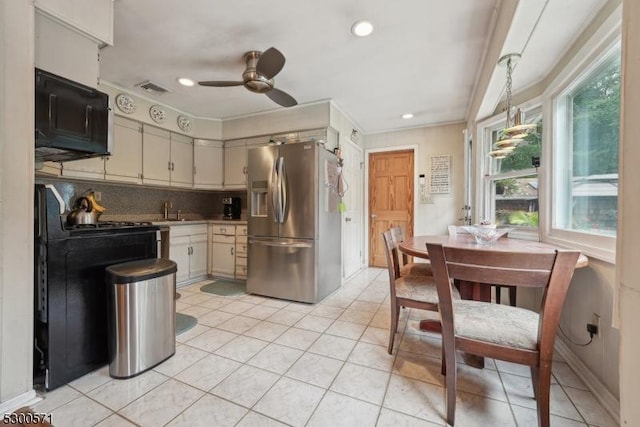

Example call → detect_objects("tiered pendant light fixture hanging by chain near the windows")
489 53 537 159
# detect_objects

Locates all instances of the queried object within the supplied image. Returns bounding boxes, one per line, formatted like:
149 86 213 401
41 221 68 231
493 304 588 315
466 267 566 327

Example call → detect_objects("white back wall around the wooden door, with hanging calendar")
364 123 465 235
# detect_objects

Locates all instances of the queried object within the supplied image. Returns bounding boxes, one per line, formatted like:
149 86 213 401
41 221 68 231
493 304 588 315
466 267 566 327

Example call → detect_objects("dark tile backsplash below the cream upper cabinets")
35 177 247 221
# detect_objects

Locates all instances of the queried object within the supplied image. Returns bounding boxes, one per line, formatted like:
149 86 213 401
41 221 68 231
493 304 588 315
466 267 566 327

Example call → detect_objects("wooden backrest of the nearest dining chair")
427 243 580 357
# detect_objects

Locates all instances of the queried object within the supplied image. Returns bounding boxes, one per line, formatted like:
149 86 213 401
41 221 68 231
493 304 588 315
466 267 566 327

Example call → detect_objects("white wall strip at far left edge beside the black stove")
0 0 35 413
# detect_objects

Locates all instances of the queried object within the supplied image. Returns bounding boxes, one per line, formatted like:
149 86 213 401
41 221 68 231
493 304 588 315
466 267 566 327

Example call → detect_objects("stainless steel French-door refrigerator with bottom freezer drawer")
247 142 342 303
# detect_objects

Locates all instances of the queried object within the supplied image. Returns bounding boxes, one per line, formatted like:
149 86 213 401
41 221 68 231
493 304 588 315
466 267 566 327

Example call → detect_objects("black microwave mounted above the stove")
35 68 111 162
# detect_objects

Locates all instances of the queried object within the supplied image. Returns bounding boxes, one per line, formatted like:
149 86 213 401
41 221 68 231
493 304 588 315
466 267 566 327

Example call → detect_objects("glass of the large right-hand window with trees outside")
552 43 621 239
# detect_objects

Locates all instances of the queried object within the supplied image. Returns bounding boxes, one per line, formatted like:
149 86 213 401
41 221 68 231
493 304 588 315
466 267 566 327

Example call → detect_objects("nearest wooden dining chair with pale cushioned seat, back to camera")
427 243 580 427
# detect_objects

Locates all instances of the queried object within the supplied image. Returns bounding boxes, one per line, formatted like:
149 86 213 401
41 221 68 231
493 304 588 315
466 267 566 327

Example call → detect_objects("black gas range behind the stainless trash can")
34 185 160 390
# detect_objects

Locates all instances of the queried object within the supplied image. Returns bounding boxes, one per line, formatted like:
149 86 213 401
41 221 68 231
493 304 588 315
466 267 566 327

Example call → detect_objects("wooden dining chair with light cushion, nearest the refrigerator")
382 230 460 354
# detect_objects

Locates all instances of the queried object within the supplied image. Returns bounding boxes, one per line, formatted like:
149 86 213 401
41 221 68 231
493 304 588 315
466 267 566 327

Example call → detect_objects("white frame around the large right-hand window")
539 8 621 263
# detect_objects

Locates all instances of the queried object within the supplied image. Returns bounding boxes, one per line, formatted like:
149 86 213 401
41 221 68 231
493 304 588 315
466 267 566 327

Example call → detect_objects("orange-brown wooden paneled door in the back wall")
369 150 414 267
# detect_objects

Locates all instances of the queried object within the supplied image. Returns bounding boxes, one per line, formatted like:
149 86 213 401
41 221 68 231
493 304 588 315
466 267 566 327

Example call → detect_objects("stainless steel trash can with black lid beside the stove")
106 258 177 378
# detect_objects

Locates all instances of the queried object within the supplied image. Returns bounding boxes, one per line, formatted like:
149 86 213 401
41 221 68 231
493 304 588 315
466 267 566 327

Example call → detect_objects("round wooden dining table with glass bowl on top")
398 234 589 368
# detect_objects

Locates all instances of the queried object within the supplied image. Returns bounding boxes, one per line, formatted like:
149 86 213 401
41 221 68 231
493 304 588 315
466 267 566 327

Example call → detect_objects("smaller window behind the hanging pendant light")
478 108 542 237
